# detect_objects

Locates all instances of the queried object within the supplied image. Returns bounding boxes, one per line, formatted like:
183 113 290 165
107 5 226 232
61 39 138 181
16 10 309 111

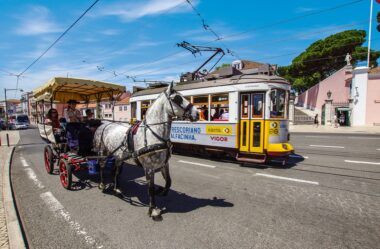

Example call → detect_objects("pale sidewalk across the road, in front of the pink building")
289 125 380 135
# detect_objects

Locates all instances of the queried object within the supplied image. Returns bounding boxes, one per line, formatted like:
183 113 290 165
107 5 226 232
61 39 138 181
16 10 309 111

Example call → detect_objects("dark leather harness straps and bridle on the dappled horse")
100 92 193 166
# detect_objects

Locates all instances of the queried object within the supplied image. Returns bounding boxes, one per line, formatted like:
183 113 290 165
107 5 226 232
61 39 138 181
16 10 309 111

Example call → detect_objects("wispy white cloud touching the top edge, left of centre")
97 0 196 22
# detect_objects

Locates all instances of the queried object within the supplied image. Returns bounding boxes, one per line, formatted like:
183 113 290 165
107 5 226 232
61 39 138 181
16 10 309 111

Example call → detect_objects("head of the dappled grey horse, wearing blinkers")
164 82 199 121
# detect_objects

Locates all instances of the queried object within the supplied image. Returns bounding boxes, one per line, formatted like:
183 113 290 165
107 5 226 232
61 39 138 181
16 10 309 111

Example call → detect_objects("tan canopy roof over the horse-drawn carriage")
33 77 126 102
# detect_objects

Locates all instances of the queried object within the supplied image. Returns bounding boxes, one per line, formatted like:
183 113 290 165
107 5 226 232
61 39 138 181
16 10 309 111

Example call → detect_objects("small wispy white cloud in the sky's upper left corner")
15 6 62 36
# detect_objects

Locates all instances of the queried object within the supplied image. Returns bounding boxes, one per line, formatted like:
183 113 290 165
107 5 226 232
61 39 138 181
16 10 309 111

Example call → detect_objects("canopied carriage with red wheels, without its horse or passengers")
33 78 125 189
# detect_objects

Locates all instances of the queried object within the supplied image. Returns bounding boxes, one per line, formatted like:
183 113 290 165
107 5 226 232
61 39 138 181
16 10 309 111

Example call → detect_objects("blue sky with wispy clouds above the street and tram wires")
0 0 380 99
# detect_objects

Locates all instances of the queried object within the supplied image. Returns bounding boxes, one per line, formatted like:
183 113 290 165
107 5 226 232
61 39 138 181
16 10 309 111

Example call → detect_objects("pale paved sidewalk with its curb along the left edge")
0 131 25 249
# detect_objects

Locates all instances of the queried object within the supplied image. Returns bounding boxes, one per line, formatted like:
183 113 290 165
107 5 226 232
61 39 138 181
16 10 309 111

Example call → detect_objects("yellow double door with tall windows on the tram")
240 92 265 153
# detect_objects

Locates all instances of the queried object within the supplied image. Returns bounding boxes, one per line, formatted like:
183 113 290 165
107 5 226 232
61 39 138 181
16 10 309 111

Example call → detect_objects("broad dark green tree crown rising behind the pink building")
278 30 380 92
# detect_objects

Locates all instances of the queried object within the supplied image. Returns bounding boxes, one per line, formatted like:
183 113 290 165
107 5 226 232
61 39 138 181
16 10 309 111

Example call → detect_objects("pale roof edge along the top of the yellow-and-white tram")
132 74 290 97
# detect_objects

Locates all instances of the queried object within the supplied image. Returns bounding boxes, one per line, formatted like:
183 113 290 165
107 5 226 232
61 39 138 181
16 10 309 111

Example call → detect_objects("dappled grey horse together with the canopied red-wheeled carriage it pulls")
33 78 199 218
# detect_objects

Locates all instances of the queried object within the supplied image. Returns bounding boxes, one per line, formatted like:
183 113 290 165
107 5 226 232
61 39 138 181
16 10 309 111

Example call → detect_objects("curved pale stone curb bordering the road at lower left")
3 147 26 249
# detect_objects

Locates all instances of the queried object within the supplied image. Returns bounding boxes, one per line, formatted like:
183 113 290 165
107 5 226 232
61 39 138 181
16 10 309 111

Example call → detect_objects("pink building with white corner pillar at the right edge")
296 66 380 126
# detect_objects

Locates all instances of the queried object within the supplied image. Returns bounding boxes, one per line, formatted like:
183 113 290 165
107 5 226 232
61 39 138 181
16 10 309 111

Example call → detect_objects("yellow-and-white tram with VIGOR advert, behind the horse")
130 70 294 164
